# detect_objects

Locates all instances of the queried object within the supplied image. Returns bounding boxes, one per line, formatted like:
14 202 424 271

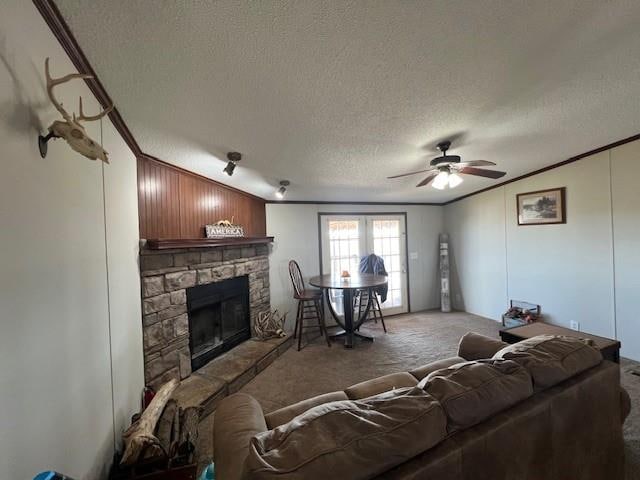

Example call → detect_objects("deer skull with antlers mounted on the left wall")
40 58 113 163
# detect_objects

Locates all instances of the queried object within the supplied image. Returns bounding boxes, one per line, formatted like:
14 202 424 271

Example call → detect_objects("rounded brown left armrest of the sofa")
213 393 267 480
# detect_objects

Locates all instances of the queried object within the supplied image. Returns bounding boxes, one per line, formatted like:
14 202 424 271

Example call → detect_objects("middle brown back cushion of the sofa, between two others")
418 360 533 432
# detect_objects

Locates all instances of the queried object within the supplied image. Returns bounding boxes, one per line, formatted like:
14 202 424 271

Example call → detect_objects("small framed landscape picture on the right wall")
516 187 567 225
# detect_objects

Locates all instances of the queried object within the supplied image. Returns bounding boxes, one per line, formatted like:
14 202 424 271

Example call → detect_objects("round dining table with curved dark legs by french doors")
309 273 387 348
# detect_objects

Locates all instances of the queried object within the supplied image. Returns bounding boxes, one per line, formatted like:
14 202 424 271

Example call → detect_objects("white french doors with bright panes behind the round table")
320 214 409 315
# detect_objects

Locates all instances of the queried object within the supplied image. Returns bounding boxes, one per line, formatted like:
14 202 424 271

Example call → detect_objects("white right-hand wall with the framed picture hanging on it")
445 142 640 359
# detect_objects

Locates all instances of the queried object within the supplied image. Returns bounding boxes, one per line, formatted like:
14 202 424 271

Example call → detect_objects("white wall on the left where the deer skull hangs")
0 0 143 480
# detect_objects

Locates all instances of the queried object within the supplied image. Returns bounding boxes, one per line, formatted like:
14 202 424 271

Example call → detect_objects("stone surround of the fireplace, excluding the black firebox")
140 244 270 388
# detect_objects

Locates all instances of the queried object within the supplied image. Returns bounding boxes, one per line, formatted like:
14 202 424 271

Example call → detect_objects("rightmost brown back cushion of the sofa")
493 335 602 390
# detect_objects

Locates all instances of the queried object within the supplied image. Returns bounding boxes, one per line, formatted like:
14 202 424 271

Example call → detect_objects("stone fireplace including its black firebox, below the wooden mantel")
140 244 270 387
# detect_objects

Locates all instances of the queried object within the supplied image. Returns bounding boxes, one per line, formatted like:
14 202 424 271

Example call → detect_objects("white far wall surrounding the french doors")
267 203 443 328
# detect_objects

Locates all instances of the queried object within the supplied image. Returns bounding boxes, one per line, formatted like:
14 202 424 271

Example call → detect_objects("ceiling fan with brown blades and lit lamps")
387 141 507 190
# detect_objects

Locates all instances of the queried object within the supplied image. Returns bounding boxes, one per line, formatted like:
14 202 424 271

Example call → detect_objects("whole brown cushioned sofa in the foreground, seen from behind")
214 334 628 480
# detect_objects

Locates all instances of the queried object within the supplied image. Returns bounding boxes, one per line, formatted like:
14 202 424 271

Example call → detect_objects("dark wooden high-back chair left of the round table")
289 260 331 351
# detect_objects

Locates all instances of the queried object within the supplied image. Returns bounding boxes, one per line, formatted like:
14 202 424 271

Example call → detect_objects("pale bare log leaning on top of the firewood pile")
120 379 178 465
